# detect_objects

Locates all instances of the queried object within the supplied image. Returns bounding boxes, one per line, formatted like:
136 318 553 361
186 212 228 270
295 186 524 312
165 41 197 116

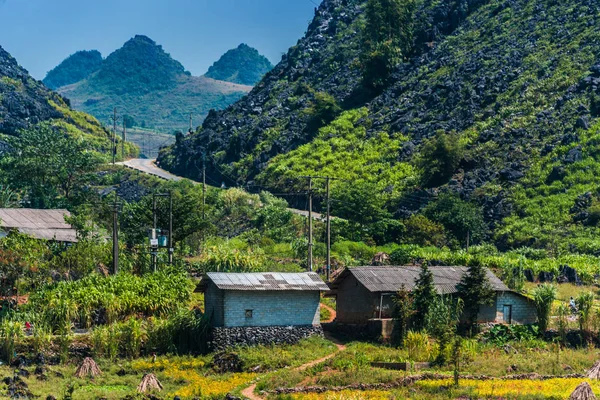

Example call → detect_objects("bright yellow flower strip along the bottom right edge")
416 378 600 399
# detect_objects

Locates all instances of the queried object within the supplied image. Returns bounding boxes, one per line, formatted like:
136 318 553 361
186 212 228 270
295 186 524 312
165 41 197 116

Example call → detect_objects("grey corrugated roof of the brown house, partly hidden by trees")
331 266 510 294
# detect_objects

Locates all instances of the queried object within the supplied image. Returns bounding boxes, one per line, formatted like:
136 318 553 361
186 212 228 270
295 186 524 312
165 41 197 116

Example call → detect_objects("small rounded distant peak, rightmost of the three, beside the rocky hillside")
204 43 273 86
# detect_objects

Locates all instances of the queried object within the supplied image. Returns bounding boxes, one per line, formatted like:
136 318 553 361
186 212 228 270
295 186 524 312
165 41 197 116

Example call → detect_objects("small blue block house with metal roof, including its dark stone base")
199 272 329 348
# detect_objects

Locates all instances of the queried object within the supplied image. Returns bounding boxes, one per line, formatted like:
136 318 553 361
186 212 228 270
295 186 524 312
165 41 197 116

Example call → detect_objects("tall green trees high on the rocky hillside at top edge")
361 0 416 89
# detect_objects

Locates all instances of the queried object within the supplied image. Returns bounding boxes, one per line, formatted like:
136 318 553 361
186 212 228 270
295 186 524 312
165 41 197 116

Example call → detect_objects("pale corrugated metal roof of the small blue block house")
200 272 329 291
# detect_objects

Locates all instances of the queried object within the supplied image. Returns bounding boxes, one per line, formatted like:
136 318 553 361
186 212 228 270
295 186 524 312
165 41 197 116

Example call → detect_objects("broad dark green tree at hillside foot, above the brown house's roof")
423 194 487 244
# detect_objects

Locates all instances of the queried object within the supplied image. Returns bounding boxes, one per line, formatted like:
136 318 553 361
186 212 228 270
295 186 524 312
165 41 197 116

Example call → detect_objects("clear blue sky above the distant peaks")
0 0 321 79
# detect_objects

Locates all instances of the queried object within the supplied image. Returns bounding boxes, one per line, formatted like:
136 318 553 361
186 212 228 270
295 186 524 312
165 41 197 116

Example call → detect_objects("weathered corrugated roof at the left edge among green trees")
0 208 77 242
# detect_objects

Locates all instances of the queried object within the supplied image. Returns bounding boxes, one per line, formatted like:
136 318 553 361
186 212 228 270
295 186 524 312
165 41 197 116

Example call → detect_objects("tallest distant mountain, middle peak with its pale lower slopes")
51 35 250 133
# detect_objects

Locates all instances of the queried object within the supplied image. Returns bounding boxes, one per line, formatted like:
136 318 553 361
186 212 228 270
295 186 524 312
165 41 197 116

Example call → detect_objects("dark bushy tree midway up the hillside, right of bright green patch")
417 131 464 187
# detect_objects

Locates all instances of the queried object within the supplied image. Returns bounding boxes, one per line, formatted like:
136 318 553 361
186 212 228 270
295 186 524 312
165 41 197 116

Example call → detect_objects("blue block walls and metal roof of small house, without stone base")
200 272 329 328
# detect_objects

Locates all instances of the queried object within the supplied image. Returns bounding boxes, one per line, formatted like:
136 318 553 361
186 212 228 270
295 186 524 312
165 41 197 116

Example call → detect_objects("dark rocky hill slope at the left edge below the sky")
0 47 61 135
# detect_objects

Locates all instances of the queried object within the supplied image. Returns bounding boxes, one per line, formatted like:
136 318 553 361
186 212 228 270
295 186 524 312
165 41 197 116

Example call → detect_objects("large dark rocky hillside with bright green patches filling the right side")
161 0 600 254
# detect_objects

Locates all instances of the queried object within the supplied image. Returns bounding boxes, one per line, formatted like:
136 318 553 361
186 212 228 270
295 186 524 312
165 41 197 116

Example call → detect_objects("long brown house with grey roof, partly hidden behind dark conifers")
326 266 537 325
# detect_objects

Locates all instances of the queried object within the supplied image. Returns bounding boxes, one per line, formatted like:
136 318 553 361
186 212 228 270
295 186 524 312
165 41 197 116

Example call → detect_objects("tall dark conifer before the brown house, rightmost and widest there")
456 264 495 332
